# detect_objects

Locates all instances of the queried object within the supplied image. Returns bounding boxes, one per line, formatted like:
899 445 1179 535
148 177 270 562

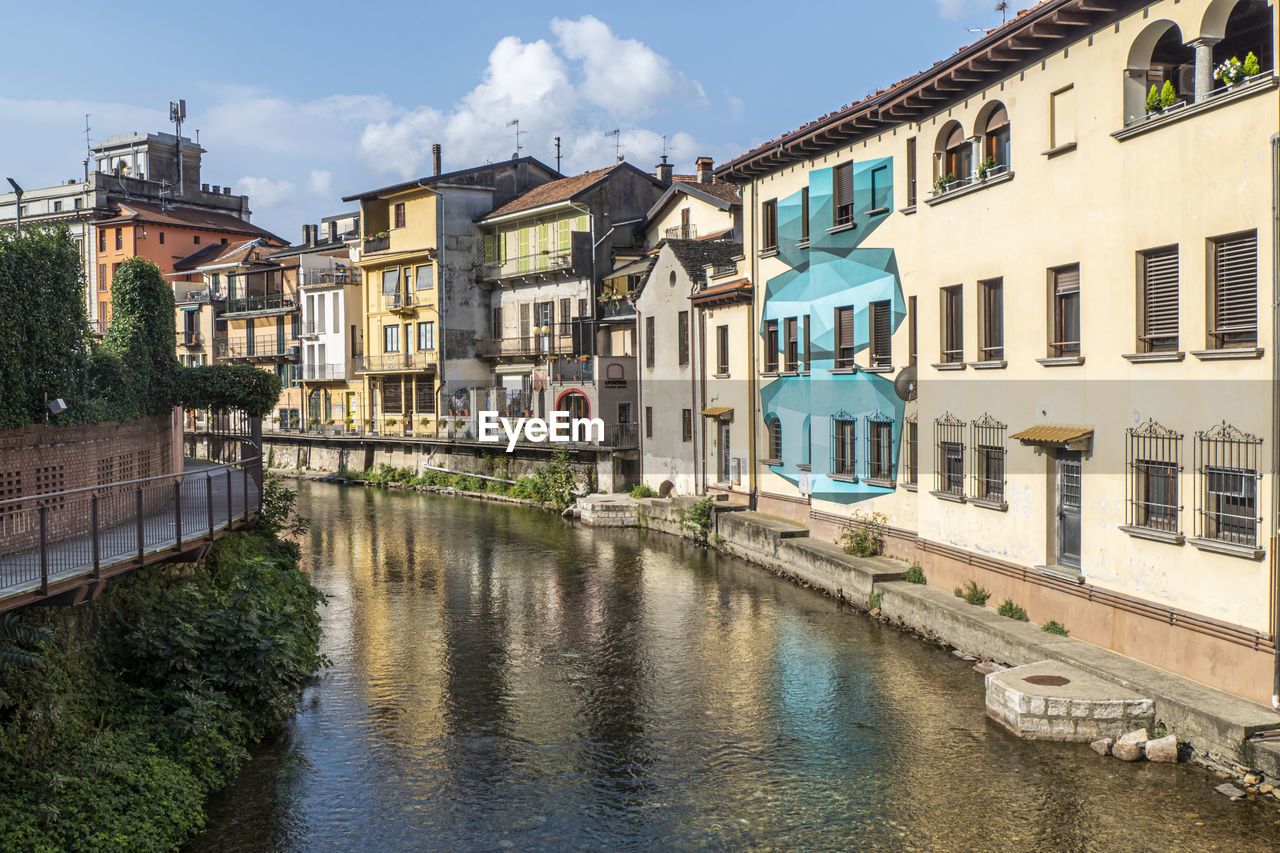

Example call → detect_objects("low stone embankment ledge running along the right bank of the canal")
579 496 1280 799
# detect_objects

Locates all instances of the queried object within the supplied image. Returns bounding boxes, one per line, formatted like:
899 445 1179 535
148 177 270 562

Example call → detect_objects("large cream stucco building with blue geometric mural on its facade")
710 0 1280 699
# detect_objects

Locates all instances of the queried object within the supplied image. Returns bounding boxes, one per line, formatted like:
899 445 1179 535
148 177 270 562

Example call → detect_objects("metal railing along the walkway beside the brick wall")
0 456 262 608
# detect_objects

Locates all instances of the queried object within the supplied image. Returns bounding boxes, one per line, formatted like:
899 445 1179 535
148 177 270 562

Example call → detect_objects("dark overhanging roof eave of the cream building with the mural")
716 0 1095 179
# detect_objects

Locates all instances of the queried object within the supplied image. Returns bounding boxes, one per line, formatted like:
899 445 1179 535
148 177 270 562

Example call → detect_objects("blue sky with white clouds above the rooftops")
0 0 1032 241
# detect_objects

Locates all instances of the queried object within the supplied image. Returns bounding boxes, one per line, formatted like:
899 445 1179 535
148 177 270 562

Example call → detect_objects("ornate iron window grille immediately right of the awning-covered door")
1125 420 1183 533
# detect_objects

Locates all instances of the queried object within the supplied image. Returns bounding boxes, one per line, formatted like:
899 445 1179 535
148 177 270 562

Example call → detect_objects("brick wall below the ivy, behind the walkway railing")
0 414 182 553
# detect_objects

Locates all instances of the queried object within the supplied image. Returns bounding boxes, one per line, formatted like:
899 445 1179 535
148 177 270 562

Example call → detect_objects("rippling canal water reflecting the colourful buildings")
189 484 1280 853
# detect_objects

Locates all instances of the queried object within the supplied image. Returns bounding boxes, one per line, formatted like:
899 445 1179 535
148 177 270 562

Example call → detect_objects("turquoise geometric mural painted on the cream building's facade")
759 158 906 503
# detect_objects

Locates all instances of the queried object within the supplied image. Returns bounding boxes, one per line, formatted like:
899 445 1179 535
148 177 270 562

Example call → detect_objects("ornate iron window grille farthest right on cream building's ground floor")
1196 421 1262 548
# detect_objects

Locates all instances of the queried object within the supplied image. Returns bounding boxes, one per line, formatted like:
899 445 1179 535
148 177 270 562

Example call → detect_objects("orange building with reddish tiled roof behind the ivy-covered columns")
92 201 288 334
